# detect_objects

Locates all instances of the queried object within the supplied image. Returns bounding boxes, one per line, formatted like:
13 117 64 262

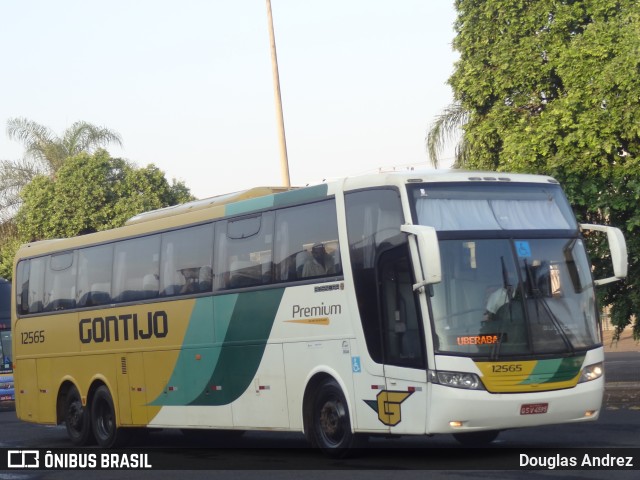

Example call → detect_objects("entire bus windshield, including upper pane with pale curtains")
414 184 601 359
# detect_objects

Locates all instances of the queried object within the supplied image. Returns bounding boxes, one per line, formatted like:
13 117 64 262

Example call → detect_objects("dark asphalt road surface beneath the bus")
0 407 640 480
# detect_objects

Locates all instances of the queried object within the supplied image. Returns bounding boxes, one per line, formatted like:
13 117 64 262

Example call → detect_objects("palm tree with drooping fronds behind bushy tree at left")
0 118 122 221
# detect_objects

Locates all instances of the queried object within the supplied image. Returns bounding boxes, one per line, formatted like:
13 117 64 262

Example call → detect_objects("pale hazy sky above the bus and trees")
0 0 457 198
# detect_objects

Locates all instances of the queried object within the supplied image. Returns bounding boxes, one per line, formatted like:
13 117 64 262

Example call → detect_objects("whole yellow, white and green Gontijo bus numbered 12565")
12 172 627 455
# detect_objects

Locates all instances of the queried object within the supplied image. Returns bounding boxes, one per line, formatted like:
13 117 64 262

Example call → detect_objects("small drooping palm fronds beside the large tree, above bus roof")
426 102 469 168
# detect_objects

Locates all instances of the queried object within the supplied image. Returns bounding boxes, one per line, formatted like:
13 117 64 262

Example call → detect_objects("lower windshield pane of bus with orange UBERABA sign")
432 239 600 358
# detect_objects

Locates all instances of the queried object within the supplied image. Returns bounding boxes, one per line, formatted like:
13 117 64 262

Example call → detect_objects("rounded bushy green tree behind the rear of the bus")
0 149 193 278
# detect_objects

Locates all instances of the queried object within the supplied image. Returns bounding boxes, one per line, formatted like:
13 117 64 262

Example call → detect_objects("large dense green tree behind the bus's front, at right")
449 0 640 339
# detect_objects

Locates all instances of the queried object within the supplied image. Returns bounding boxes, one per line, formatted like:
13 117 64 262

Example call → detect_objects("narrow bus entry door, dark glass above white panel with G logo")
378 248 427 434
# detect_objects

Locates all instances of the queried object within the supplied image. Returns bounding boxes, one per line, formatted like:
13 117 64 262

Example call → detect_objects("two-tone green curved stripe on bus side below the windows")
151 288 284 405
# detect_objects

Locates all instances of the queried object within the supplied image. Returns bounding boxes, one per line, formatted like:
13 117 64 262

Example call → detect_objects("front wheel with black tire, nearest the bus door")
309 379 359 457
